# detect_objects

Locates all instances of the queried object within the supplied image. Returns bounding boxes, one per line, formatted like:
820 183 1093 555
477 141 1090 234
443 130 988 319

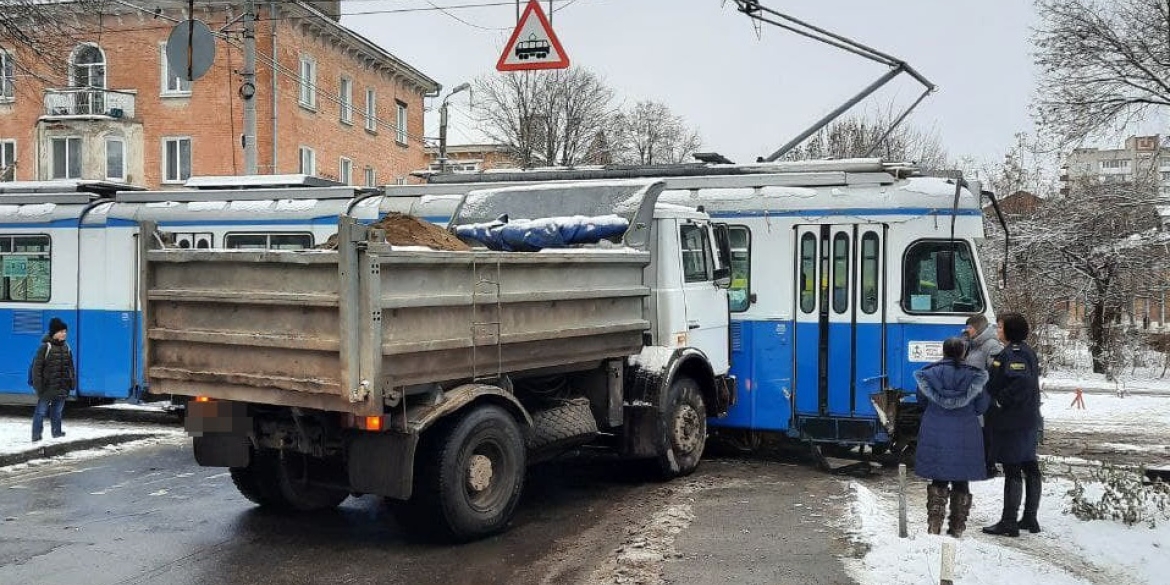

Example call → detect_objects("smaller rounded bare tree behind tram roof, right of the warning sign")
607 101 703 165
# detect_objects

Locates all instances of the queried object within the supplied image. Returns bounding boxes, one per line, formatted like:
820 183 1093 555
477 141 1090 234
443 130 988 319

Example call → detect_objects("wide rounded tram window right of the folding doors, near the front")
902 240 983 312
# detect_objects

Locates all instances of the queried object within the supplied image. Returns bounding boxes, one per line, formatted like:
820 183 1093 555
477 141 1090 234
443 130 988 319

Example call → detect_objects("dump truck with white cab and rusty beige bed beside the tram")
140 180 736 541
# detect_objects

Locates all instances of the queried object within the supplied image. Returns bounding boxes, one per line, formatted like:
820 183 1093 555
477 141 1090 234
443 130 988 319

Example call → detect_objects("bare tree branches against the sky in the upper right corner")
1034 0 1170 144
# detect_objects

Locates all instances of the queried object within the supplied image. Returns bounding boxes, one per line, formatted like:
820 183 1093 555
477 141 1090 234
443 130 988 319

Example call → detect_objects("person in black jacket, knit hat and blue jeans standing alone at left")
32 317 77 442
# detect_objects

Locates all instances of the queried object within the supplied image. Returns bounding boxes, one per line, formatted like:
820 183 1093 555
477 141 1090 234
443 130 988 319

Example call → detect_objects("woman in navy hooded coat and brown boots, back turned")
914 337 991 538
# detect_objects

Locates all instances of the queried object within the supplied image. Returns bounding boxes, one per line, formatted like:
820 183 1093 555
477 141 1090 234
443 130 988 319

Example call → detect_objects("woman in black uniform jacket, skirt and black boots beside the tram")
983 312 1041 536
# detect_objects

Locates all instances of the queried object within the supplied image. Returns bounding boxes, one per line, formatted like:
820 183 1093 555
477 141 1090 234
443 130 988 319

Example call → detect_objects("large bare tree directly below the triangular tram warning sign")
475 67 613 167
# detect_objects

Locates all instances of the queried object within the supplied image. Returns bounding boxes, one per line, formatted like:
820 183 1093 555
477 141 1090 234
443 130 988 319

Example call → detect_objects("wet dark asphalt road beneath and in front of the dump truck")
0 441 861 585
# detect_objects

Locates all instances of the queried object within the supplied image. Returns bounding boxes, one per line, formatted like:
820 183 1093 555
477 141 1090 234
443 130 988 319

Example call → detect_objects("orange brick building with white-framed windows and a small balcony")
0 0 440 188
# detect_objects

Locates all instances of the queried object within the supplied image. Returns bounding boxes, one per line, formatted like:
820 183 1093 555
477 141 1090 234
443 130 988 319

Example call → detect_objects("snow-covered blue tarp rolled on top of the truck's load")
455 215 629 252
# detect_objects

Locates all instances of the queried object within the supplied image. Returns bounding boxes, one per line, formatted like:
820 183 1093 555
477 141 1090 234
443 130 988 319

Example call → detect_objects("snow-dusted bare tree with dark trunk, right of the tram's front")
1006 175 1166 373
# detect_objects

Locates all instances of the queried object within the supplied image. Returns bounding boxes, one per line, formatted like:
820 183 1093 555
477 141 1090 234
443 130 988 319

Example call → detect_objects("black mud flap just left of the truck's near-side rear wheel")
346 433 419 500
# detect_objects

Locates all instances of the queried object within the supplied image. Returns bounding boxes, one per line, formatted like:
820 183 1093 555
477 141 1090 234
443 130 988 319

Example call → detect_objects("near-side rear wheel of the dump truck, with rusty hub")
410 406 524 542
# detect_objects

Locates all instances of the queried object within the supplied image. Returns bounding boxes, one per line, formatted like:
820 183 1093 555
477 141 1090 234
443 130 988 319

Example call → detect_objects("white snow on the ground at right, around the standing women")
845 374 1170 585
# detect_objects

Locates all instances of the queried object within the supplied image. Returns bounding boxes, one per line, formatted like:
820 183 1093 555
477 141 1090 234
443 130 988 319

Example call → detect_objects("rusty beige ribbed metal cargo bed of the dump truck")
143 220 649 414
